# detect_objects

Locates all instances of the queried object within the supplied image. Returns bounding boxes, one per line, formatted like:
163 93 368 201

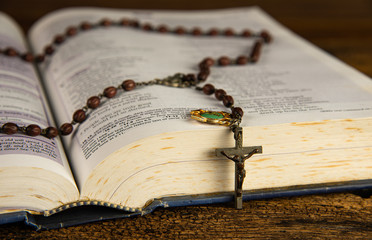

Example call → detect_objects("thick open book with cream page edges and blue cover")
0 8 372 227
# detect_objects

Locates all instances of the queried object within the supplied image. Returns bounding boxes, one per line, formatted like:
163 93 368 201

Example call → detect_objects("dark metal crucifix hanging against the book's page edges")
216 127 262 209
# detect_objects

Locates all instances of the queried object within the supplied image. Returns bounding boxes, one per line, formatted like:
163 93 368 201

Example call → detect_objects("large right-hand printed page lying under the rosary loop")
30 8 372 186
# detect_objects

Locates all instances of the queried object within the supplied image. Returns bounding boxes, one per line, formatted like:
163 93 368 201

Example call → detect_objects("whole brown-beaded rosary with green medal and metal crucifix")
0 19 272 209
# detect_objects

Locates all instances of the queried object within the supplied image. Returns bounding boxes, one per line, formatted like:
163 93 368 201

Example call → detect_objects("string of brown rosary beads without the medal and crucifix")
0 18 272 138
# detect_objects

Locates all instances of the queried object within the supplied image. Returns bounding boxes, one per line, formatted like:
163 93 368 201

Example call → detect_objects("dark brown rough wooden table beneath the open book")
0 0 372 239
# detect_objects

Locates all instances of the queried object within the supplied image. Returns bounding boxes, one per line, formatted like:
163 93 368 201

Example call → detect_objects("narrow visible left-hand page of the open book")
0 13 75 184
